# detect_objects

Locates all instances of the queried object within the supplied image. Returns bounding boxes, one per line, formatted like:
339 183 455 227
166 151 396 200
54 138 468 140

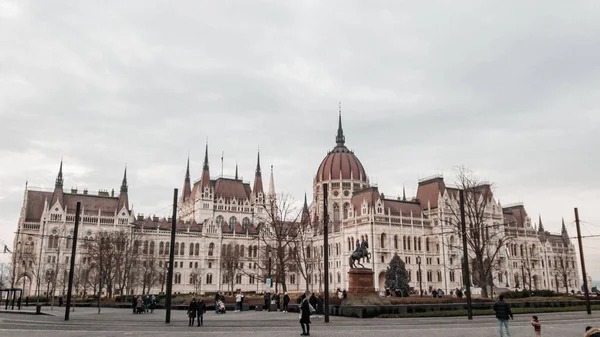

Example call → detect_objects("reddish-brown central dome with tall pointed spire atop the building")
315 113 367 183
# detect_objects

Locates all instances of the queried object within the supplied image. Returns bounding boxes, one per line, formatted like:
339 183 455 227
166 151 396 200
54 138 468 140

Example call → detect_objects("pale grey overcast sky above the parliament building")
0 0 600 280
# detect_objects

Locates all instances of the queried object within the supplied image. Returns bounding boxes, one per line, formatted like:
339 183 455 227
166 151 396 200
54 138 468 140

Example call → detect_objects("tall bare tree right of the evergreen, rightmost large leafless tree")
445 167 511 297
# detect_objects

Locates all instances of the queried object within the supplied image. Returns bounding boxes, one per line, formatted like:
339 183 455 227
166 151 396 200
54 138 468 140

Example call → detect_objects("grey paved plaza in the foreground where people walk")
0 308 600 337
